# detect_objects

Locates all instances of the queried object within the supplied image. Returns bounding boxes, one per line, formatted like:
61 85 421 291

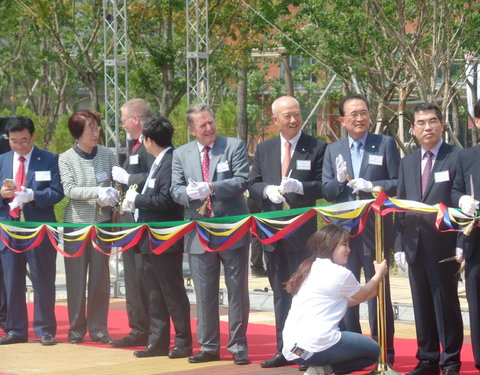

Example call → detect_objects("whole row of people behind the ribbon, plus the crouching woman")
0 94 480 375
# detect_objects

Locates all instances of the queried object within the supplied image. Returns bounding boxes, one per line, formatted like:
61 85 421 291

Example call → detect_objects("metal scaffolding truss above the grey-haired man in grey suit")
186 0 209 106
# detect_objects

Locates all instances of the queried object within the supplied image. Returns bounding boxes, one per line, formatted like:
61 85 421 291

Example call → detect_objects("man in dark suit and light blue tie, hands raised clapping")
322 94 400 364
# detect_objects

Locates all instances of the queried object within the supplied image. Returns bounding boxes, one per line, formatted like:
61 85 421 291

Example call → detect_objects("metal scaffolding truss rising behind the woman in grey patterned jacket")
103 0 128 152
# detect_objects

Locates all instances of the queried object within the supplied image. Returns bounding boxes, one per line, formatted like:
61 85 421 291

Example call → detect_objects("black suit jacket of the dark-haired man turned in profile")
135 148 183 254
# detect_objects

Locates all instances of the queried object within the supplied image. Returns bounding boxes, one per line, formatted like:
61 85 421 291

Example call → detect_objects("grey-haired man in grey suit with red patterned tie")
170 104 250 365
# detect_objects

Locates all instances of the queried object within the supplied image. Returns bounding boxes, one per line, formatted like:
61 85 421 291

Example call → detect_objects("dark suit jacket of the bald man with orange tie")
248 132 326 251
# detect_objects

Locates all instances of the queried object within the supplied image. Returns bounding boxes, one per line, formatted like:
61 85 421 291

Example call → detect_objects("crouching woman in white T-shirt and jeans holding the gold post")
282 224 388 375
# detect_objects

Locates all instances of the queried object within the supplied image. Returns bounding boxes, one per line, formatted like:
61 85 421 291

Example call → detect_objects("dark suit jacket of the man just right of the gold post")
395 142 460 263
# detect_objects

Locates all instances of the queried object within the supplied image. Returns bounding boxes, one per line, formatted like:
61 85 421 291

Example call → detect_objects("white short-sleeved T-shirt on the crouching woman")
282 258 361 361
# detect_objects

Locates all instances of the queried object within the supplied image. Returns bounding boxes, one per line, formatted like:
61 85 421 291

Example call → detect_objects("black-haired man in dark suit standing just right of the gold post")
395 103 463 375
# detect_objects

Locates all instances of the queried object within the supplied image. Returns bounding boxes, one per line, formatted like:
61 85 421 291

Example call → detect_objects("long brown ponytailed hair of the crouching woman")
285 224 349 295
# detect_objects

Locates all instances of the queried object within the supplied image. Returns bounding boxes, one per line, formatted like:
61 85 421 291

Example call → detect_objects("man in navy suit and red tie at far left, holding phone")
0 116 63 345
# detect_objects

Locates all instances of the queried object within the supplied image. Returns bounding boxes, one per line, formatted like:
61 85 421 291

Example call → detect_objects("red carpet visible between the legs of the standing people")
24 304 478 375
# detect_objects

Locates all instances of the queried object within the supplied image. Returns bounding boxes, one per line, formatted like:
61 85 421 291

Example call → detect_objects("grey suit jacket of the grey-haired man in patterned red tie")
170 135 248 254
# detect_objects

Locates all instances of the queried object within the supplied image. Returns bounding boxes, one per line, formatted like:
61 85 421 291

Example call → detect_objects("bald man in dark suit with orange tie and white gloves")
248 96 326 368
